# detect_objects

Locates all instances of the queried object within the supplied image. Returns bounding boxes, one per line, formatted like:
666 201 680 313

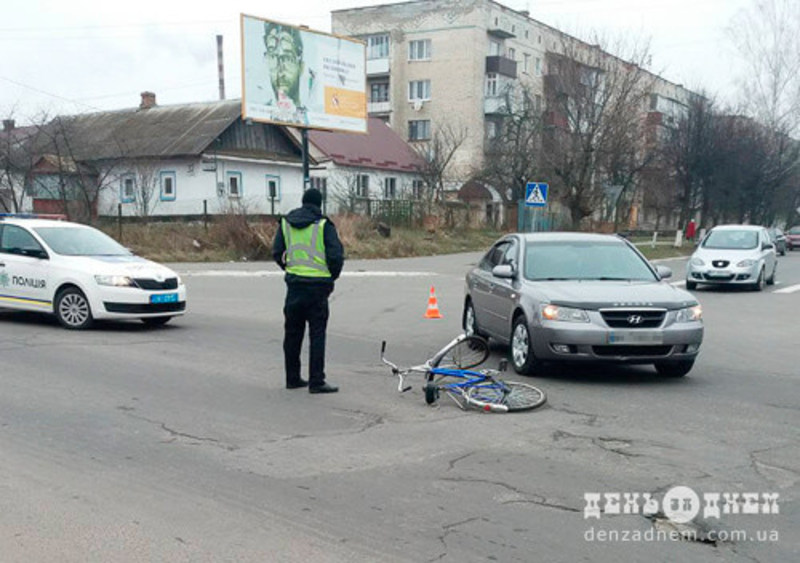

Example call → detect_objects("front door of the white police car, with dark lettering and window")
0 225 52 311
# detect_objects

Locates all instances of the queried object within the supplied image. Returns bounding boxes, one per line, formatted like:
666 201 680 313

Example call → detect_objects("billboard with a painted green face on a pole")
241 14 367 133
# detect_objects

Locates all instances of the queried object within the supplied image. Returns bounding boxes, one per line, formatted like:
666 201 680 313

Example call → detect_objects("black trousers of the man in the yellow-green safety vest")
283 283 333 387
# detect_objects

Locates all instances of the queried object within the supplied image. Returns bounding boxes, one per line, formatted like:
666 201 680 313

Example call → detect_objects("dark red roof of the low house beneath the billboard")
308 117 422 172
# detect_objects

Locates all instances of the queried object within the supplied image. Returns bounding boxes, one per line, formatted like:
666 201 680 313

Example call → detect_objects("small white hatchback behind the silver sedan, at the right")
686 225 778 291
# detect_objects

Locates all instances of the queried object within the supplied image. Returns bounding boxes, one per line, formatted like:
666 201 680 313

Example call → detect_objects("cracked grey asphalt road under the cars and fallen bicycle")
0 252 800 563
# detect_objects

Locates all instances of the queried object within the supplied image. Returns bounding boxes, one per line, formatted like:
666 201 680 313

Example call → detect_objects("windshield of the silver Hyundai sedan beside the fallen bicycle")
525 241 657 281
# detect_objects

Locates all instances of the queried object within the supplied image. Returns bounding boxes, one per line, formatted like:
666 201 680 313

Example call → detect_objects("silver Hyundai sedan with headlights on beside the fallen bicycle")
463 233 703 377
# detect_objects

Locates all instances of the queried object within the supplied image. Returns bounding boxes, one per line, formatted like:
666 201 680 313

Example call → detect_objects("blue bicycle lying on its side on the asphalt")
381 334 547 412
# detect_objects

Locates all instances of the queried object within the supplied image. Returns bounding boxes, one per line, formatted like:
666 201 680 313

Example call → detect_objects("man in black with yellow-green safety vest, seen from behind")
272 188 344 393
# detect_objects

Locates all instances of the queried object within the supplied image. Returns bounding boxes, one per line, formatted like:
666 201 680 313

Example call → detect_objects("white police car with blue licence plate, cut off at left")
0 214 186 329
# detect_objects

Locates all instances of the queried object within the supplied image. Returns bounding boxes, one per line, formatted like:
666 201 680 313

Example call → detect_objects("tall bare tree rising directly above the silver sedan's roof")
543 36 655 229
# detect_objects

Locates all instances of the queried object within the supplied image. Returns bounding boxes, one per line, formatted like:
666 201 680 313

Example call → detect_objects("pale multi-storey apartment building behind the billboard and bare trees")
332 0 692 229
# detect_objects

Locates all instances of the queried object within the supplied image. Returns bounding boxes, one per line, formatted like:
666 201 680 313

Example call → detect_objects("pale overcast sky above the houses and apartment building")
0 0 753 124
